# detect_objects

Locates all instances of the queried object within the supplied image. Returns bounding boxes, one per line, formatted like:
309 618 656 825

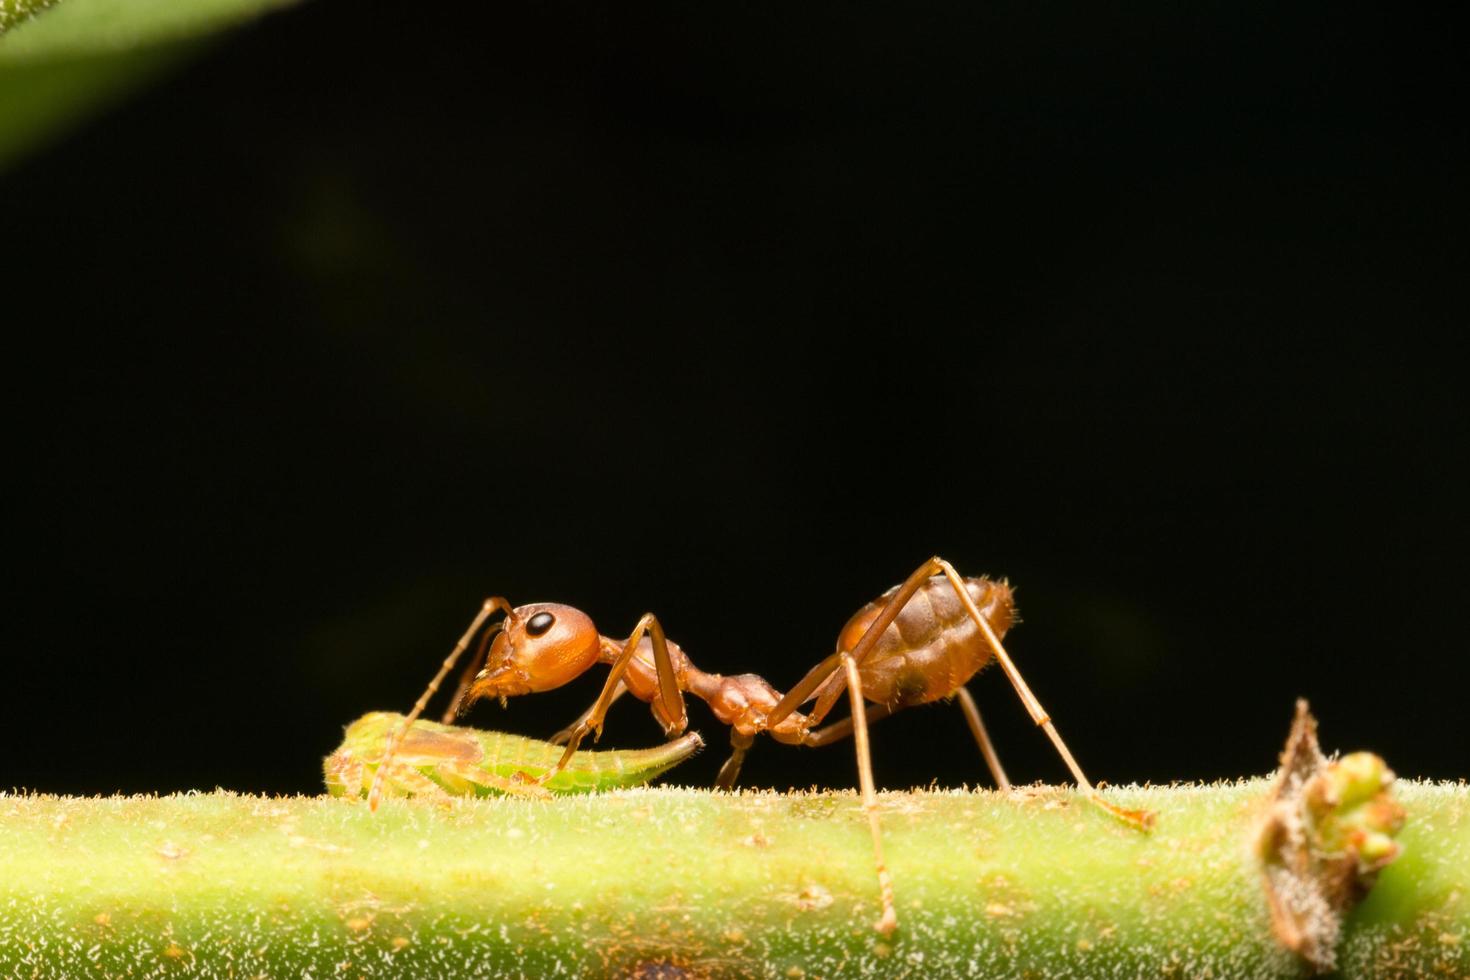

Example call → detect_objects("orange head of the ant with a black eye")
459 602 601 711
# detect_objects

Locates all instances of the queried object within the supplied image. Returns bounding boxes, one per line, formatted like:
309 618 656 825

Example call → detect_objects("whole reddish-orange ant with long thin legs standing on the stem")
369 557 1154 933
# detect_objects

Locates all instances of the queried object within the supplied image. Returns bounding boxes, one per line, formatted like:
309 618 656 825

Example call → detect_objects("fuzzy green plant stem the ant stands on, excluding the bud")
0 780 1470 977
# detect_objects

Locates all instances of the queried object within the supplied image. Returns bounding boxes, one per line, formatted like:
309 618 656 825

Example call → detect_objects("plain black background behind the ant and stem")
0 0 1470 793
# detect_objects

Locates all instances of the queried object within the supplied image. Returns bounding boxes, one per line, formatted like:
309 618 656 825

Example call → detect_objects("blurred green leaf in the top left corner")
0 0 294 170
